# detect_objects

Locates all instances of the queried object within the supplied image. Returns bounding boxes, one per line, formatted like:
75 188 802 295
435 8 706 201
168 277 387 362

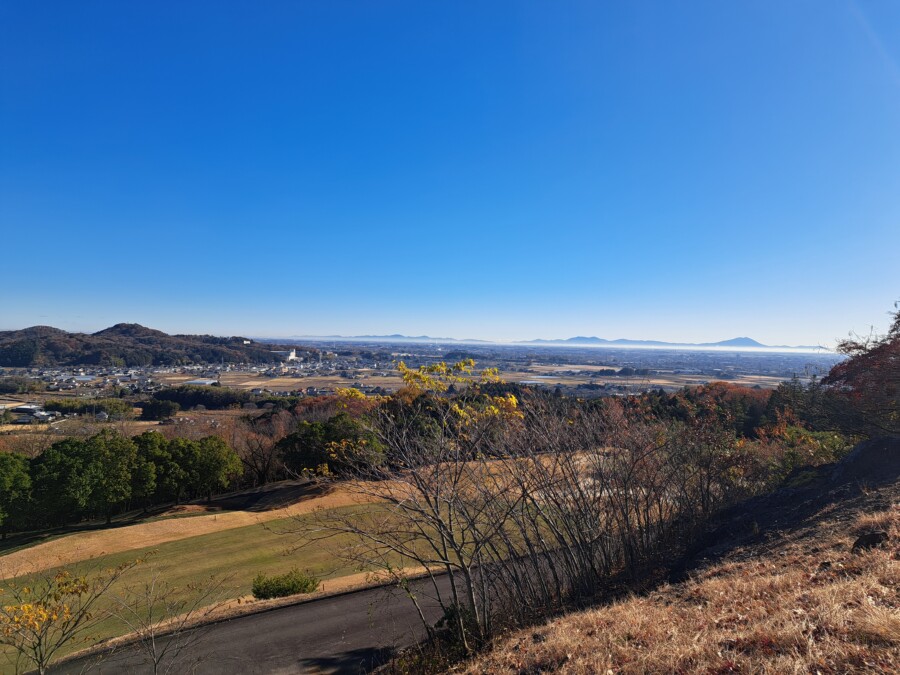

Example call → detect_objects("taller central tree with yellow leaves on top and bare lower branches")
296 359 523 650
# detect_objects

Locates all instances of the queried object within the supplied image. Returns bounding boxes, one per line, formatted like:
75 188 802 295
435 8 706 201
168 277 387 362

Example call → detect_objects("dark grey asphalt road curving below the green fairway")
50 579 447 675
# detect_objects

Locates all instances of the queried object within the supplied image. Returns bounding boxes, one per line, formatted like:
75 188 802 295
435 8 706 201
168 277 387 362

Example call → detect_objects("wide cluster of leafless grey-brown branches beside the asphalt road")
294 397 739 649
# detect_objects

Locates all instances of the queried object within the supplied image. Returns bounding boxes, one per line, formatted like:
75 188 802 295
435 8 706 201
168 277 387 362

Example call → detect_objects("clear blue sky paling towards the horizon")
0 0 900 344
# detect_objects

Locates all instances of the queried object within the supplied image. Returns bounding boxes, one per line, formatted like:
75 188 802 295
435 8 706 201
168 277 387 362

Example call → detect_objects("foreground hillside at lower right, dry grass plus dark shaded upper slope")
456 440 900 675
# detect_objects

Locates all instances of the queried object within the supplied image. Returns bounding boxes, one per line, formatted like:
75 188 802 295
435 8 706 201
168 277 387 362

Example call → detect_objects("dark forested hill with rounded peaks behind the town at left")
0 323 310 368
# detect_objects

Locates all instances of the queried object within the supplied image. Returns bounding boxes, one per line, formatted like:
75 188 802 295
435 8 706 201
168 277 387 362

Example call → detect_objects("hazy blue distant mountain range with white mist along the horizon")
270 333 828 351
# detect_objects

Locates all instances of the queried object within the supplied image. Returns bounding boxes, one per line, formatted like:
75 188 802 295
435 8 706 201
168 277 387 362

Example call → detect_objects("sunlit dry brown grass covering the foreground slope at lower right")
459 496 900 675
